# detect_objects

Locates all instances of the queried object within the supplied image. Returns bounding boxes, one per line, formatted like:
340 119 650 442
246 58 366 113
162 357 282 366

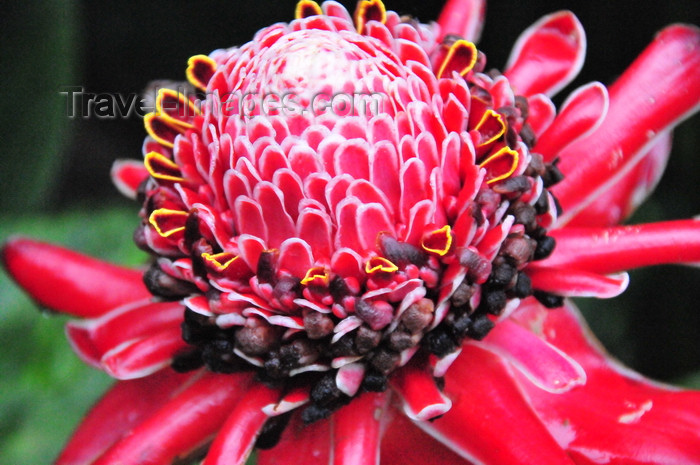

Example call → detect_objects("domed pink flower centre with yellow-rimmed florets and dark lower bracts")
135 2 559 421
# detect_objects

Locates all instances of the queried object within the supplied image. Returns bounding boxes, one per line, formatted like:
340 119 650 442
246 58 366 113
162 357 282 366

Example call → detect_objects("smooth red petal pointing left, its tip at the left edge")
1 238 151 318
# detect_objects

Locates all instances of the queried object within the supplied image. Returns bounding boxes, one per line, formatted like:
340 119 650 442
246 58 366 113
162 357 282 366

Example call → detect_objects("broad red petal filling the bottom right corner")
516 302 700 465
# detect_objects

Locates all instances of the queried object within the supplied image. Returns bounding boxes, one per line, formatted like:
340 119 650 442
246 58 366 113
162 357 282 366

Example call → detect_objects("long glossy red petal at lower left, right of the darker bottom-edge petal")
91 373 252 465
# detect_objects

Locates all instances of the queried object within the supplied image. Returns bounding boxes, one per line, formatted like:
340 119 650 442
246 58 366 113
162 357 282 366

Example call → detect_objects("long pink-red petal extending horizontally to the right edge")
537 220 700 273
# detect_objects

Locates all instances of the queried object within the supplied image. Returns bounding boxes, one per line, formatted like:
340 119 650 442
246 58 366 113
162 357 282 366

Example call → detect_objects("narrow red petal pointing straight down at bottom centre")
332 392 387 465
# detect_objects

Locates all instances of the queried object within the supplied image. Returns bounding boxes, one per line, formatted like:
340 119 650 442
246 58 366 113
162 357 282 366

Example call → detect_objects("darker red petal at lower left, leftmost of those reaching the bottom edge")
56 370 194 465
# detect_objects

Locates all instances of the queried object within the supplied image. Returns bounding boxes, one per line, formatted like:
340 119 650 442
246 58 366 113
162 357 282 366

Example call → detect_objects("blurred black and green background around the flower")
0 0 700 465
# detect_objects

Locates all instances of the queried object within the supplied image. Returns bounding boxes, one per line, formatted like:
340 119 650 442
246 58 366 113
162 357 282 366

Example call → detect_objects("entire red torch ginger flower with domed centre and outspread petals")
3 0 700 465
